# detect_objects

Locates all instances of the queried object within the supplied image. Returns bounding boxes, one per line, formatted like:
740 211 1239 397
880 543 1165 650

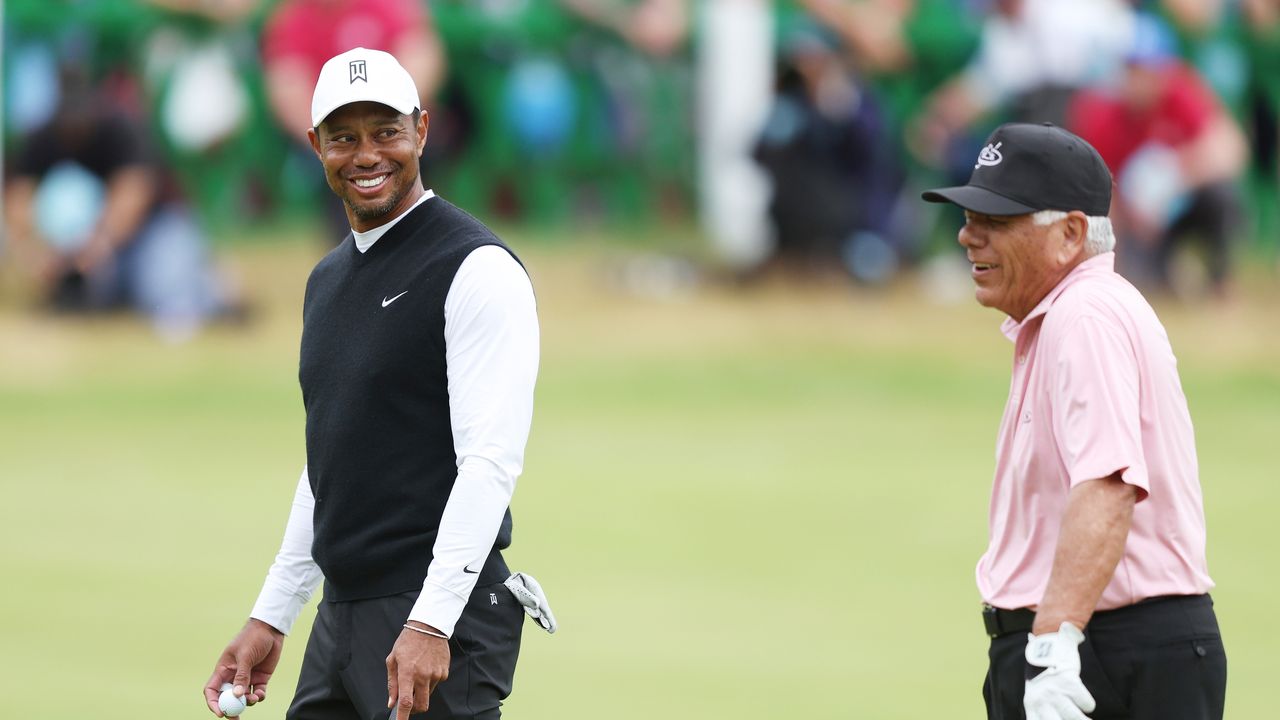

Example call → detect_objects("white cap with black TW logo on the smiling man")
311 47 417 126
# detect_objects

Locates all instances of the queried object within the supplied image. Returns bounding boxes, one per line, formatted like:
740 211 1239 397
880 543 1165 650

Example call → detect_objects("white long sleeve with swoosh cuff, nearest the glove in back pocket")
408 246 539 635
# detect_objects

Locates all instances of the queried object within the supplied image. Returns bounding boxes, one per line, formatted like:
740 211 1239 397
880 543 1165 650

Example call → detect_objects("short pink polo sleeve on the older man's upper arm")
1052 316 1149 500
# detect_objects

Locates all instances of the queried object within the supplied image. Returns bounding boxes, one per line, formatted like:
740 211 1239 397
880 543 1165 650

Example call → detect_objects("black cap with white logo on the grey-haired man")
920 123 1111 217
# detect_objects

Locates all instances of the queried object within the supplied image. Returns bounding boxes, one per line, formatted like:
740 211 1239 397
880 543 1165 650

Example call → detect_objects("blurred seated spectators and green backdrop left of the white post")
0 0 692 330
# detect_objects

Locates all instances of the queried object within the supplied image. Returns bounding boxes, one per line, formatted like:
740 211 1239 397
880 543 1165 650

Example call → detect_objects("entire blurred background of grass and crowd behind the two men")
0 0 1280 720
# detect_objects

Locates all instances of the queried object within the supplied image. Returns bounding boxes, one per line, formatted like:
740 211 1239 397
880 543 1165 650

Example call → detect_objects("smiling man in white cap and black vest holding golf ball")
205 47 556 720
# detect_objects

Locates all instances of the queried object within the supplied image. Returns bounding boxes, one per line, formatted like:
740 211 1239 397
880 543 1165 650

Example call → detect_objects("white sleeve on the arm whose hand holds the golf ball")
248 468 324 634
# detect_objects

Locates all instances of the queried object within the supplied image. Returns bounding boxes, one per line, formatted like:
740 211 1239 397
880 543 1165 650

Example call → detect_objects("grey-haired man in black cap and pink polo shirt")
924 124 1226 720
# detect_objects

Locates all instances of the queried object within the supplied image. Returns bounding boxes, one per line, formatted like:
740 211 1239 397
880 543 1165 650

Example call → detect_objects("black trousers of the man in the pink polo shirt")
982 594 1226 720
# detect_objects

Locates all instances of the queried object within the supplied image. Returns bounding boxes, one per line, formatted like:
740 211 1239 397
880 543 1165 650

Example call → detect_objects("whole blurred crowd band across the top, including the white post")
0 0 1280 334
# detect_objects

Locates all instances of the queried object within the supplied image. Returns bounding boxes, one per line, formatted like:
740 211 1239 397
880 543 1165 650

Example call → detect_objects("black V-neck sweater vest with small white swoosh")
298 197 518 601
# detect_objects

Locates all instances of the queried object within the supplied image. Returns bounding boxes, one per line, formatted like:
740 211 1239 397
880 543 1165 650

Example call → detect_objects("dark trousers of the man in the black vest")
285 582 525 720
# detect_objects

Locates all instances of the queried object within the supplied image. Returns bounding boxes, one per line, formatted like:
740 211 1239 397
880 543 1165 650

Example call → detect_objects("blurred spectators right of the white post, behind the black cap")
759 0 1280 295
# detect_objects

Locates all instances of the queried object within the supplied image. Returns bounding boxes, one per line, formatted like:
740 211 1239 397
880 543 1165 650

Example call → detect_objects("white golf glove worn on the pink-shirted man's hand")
1023 623 1094 720
